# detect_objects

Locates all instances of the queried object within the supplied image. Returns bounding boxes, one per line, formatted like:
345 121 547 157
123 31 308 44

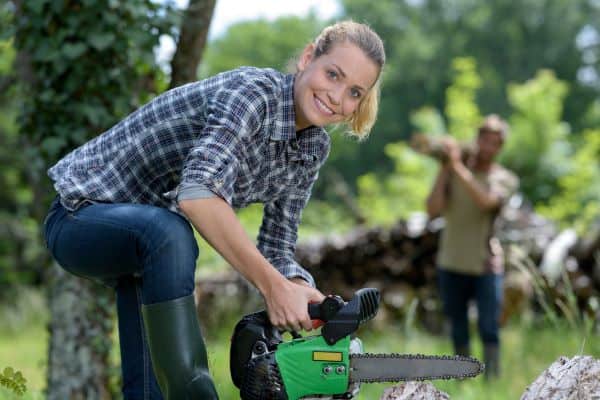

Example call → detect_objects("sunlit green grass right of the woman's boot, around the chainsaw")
209 323 600 400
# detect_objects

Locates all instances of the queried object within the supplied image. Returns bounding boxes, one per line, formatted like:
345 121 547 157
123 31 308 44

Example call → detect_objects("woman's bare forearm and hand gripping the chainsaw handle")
179 197 324 331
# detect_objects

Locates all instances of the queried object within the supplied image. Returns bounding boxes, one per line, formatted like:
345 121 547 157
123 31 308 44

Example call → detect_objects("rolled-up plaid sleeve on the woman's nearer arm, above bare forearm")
181 80 267 204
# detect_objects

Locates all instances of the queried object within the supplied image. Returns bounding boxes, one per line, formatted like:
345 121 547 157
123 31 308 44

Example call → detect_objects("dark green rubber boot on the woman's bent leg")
142 295 219 400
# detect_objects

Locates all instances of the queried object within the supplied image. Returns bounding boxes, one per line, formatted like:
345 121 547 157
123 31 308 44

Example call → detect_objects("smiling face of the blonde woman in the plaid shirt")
294 43 379 130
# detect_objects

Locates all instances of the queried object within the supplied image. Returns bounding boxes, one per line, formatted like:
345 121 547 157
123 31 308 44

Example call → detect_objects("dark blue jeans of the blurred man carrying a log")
437 268 503 349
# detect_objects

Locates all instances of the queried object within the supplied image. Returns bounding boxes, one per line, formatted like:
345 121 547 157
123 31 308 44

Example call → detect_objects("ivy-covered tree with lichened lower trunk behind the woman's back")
13 0 178 399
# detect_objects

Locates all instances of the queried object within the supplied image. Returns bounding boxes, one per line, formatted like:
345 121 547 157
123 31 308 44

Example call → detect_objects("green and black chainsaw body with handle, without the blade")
230 289 379 400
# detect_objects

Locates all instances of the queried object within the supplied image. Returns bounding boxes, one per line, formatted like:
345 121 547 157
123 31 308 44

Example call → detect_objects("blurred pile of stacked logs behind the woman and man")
198 203 600 333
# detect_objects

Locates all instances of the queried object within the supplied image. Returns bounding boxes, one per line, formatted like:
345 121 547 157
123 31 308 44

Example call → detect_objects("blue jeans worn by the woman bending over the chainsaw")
44 200 198 400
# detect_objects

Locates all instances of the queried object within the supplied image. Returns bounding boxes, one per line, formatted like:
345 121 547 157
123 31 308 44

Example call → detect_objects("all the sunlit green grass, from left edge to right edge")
0 293 600 400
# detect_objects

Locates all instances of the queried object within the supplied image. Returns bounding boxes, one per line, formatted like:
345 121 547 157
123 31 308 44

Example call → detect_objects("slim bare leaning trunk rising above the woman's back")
170 0 216 88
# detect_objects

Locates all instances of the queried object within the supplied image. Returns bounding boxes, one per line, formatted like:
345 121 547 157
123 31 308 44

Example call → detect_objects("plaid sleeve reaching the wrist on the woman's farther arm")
258 171 318 287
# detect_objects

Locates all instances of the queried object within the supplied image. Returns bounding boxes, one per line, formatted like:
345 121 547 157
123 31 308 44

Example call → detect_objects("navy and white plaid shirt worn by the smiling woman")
48 67 330 286
